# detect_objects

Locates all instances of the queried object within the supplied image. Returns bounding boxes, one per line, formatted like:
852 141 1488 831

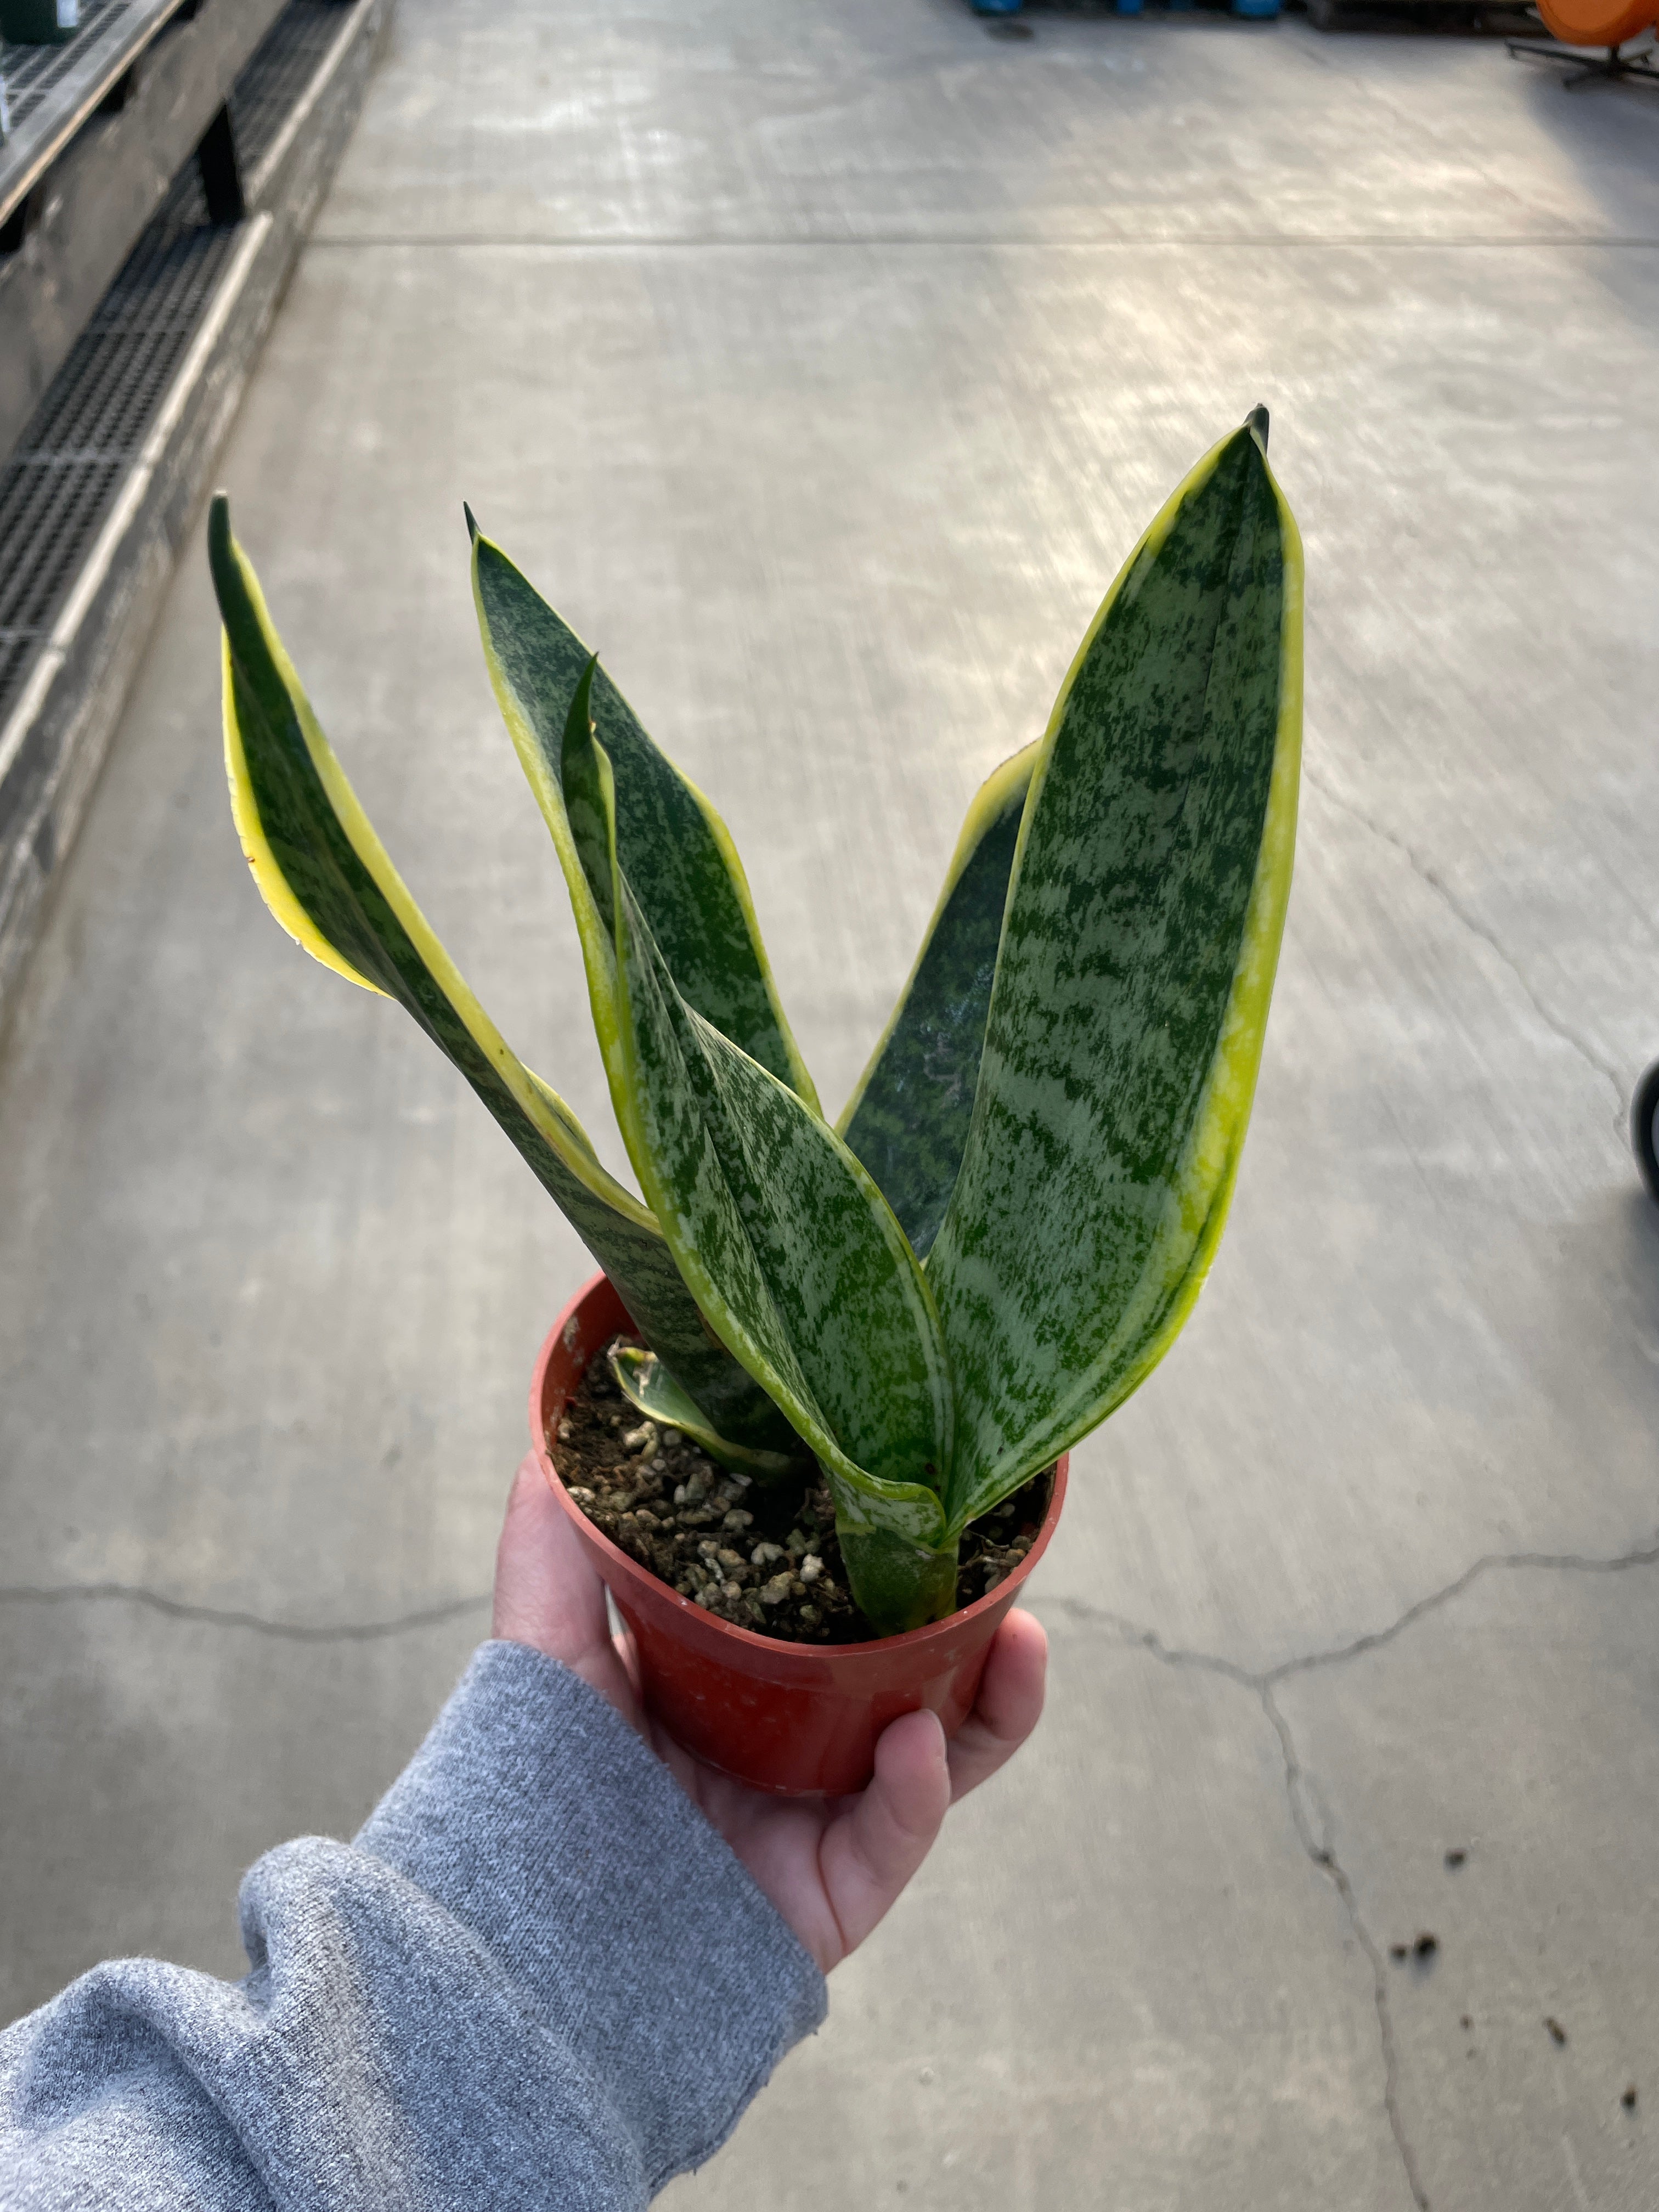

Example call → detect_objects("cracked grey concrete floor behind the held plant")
0 0 1659 2212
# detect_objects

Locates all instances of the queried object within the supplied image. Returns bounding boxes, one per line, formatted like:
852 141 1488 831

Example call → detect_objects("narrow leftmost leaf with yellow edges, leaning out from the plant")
208 498 778 1438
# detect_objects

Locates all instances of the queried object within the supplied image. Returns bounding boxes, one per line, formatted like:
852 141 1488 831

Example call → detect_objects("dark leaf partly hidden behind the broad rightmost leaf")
836 743 1037 1259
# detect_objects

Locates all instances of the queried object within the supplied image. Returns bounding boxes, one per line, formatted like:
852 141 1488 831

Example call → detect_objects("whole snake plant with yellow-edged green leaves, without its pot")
208 409 1301 1635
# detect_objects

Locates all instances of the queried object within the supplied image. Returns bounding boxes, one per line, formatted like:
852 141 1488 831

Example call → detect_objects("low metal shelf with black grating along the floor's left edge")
0 0 380 1026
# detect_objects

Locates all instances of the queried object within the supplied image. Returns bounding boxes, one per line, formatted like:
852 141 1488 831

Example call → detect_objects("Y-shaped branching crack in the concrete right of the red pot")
1033 1535 1659 2212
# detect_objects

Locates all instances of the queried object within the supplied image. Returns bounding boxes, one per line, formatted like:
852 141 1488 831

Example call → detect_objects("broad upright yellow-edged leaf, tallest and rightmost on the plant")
929 429 1303 1528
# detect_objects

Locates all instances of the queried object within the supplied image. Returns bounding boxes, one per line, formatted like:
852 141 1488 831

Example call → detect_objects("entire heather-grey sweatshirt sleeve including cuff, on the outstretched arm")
0 1644 825 2212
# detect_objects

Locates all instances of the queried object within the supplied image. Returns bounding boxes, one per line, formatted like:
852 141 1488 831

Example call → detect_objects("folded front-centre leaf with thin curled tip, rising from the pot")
562 714 953 1633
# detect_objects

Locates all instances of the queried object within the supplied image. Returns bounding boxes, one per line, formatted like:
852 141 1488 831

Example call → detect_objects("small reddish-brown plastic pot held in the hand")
531 1274 1066 1796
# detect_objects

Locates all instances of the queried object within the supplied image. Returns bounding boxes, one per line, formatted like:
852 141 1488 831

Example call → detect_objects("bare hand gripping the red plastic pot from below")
495 1453 1048 1973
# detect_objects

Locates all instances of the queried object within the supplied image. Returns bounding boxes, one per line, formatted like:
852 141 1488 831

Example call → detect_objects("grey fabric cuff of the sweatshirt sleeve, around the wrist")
356 1644 827 2190
